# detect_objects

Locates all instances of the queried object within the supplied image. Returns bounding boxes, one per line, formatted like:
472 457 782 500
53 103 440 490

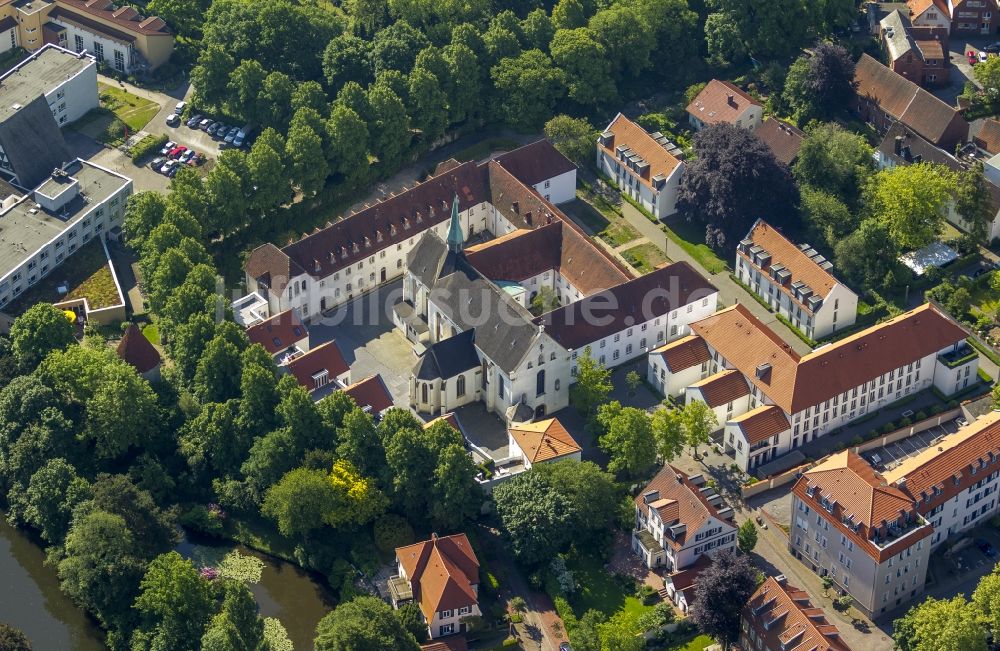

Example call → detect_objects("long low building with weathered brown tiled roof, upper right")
852 54 969 151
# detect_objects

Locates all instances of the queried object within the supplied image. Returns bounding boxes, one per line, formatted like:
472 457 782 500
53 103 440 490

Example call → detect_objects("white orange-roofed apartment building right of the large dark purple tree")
735 219 858 339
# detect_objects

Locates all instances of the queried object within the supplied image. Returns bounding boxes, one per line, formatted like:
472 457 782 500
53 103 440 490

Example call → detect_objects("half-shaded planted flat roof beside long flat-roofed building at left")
7 240 119 315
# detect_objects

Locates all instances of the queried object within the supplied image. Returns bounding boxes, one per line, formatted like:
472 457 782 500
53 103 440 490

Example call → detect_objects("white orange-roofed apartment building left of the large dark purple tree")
597 113 684 219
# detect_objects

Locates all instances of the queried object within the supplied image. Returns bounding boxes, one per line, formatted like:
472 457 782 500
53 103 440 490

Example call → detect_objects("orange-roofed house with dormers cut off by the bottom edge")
740 575 851 651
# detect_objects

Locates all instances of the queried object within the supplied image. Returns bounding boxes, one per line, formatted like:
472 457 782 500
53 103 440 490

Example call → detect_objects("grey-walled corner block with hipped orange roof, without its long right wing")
788 450 934 618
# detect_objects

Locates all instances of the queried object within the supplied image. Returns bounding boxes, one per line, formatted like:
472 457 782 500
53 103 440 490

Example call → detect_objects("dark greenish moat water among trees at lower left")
0 513 334 651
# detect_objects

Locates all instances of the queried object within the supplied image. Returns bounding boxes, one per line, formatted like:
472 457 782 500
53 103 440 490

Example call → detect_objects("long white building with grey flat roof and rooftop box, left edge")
0 159 132 309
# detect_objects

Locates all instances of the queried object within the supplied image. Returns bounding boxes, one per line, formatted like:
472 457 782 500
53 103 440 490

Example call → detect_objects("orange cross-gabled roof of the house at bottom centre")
396 533 479 621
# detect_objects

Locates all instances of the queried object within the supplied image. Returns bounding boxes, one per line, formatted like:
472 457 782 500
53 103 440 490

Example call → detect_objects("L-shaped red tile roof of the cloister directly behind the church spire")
466 220 631 294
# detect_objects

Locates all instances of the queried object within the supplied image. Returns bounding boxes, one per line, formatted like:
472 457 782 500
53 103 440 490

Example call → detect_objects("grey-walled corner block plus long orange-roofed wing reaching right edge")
789 411 1000 617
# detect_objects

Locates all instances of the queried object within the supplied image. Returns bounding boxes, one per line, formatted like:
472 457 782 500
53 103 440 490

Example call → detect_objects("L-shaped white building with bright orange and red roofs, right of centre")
648 304 979 471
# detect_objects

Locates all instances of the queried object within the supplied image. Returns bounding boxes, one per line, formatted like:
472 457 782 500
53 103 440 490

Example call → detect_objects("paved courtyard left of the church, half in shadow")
309 280 417 409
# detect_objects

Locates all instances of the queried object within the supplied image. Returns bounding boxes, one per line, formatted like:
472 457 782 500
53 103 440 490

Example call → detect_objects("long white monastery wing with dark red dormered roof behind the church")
244 140 576 321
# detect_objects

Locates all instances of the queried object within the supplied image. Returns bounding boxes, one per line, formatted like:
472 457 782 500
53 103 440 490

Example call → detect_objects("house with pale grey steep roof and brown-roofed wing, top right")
881 11 950 86
